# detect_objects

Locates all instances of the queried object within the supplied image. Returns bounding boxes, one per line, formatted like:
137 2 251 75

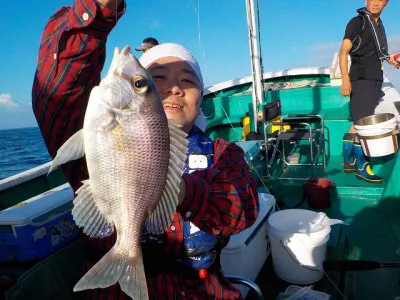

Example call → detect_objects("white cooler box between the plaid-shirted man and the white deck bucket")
221 192 275 297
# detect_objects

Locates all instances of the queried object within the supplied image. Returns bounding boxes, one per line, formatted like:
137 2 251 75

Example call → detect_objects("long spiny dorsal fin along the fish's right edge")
145 120 188 233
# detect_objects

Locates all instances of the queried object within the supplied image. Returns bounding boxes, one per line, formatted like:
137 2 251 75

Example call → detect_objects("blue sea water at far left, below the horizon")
0 127 51 180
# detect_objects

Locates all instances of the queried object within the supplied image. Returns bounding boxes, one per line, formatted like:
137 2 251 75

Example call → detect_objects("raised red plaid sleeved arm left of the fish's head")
32 0 125 190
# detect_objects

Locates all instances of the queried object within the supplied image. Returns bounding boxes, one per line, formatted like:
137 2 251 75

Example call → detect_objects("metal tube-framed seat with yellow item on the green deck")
263 100 326 180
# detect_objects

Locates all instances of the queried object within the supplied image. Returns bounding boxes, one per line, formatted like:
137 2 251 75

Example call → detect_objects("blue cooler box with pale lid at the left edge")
0 183 79 262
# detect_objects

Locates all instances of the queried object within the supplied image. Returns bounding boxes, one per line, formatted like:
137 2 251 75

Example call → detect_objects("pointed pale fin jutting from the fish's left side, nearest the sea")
47 129 85 174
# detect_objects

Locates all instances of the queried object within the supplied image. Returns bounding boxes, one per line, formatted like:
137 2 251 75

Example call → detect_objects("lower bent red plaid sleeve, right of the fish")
179 139 259 244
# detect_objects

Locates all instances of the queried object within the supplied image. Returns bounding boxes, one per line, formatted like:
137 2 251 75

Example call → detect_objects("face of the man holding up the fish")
148 57 202 132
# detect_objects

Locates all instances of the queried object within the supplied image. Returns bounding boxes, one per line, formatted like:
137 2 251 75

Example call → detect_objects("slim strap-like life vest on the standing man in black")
350 7 389 61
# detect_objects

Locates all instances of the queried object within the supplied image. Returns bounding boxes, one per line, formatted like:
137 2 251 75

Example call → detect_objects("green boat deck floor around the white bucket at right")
247 155 400 299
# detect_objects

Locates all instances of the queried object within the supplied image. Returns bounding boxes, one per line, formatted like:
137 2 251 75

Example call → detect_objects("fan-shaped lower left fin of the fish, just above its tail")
72 180 114 238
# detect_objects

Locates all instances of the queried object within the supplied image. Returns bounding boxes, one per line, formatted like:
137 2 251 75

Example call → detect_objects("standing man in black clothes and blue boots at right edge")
339 0 399 182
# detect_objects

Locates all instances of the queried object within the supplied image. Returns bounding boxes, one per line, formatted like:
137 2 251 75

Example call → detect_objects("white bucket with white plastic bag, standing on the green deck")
268 209 331 284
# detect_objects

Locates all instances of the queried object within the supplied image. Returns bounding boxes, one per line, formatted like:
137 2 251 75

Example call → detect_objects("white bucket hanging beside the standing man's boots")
354 113 398 157
